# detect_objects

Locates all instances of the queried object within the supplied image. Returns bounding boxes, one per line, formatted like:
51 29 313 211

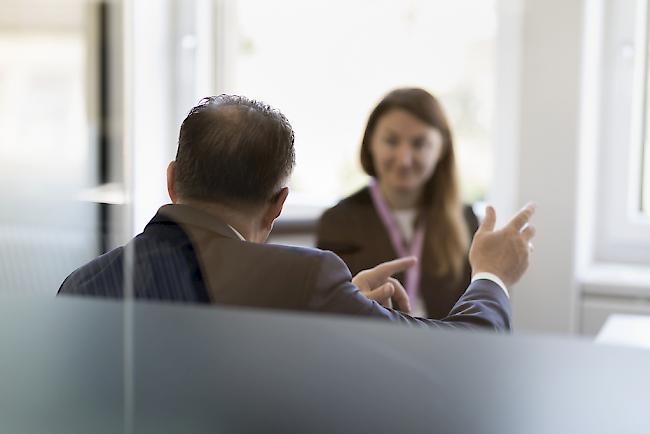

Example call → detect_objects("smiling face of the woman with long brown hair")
370 109 443 190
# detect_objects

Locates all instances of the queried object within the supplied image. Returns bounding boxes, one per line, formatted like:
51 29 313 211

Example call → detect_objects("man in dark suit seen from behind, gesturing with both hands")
59 95 535 330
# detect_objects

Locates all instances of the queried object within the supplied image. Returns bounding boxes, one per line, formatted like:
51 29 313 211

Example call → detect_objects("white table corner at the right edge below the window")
596 314 650 350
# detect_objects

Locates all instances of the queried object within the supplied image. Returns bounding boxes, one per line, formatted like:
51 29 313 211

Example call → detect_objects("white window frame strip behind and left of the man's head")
122 0 216 240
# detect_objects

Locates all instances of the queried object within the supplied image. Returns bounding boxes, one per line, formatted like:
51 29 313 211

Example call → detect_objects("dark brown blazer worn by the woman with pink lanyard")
317 187 479 319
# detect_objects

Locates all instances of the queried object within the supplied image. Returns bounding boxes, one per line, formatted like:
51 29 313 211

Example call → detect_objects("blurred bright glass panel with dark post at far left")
0 0 124 294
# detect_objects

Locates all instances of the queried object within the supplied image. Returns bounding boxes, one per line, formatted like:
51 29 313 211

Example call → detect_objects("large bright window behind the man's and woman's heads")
219 0 496 210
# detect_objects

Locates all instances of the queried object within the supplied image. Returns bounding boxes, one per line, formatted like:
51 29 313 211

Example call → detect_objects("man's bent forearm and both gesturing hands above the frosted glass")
311 205 535 331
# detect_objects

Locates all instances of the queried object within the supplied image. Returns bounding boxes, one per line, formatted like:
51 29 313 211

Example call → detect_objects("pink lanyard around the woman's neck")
370 179 424 297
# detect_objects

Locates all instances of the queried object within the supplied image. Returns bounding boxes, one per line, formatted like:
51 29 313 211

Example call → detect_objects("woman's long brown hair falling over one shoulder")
361 88 470 277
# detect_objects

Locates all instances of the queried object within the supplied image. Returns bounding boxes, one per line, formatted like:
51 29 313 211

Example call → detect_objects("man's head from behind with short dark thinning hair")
168 95 295 241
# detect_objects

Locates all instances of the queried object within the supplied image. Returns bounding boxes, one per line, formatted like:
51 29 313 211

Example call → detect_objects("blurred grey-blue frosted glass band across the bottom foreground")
0 298 650 434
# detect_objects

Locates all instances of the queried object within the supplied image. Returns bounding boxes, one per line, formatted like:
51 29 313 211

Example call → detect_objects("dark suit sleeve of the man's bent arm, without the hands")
309 252 512 331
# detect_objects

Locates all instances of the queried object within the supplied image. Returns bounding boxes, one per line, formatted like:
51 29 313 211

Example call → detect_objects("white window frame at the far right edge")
579 0 650 264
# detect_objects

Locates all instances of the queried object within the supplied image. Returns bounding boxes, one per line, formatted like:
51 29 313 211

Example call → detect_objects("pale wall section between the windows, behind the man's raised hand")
493 0 583 333
